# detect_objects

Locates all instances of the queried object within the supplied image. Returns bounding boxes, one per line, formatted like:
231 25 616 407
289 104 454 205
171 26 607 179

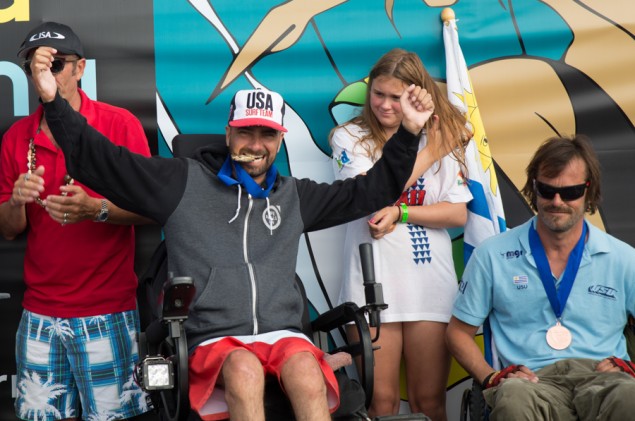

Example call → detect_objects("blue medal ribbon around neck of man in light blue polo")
529 222 587 320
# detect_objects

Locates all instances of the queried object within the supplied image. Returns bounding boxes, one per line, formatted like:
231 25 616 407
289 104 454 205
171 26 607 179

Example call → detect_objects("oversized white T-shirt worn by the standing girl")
331 124 472 323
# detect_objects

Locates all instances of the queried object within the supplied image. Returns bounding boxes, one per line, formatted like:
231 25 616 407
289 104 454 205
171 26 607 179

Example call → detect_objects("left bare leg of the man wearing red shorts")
219 349 265 421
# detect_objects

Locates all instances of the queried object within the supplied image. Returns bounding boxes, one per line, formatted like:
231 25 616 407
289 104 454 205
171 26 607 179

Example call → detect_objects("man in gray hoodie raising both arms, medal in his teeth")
31 44 434 420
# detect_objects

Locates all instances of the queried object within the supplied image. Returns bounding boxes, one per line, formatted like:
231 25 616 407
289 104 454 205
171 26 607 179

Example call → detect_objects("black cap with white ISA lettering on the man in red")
18 22 84 58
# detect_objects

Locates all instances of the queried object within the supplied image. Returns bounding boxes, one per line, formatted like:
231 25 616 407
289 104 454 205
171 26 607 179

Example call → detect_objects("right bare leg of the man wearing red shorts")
280 352 331 421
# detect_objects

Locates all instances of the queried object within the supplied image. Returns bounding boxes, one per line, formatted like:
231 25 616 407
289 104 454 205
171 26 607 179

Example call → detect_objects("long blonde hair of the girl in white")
329 48 472 178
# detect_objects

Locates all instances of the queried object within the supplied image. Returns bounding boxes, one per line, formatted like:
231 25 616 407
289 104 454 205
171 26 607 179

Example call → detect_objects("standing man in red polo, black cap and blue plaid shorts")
0 22 150 420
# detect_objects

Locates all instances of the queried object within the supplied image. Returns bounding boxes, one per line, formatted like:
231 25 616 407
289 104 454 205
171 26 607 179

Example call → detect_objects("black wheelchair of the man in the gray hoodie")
135 238 428 421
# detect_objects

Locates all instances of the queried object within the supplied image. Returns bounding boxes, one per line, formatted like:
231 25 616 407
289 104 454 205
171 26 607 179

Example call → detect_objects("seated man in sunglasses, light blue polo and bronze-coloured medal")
447 135 635 421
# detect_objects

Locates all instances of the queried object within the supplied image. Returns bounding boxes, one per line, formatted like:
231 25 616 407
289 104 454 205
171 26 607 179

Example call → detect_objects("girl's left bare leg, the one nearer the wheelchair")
347 323 403 418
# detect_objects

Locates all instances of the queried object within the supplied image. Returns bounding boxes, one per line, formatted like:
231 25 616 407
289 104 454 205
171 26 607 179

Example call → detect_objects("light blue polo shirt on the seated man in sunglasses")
452 217 635 370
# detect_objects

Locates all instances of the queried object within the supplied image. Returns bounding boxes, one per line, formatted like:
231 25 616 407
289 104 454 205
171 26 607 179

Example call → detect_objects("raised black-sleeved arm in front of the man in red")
31 47 187 224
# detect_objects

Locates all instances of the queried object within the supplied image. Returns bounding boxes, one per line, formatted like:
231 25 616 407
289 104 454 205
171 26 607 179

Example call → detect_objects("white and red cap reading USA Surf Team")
227 89 287 132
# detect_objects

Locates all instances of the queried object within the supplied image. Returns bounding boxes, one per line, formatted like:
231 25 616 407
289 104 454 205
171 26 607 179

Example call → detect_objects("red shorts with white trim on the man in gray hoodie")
189 334 340 421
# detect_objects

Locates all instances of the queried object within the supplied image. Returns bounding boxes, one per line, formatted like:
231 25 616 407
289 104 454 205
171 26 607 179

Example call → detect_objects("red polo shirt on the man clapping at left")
0 90 150 318
